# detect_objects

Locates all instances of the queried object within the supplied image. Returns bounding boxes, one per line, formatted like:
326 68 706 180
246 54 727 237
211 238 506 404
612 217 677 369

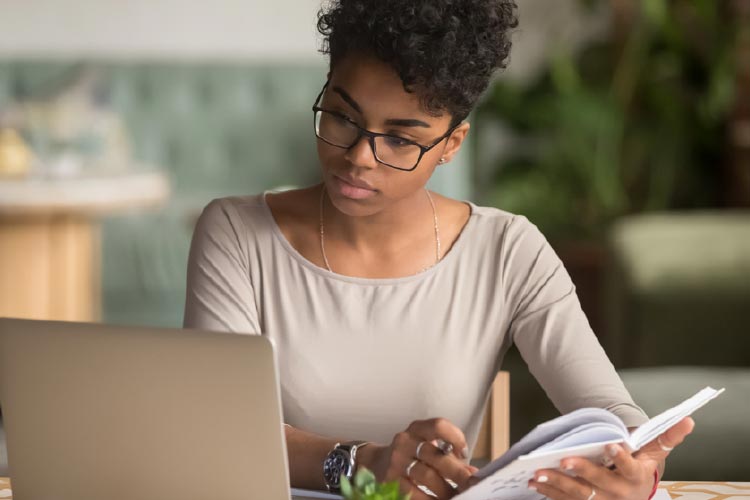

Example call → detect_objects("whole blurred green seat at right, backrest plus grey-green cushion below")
602 212 750 480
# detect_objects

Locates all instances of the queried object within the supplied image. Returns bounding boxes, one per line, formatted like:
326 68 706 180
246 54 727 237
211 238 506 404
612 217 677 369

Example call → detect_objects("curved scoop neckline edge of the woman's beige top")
260 191 477 285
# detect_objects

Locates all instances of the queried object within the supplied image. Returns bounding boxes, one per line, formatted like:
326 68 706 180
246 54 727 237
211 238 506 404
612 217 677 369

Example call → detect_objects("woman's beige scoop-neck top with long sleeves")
185 195 646 450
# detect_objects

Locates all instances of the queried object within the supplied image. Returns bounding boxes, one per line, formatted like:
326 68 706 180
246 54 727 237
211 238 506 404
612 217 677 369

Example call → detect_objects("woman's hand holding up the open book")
529 417 695 500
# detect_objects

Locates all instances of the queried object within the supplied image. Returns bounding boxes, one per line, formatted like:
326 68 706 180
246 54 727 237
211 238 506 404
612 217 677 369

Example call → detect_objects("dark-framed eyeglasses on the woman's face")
312 82 458 172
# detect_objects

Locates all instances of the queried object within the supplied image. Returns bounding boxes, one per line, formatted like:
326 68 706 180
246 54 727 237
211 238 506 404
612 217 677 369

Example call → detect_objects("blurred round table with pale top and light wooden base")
0 171 169 320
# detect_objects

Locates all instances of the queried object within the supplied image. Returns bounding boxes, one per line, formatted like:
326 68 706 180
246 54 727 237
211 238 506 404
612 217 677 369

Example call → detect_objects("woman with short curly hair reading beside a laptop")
185 0 692 500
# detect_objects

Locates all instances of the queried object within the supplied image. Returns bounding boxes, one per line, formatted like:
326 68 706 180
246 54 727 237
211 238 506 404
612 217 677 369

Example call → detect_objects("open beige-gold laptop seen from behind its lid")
0 318 334 500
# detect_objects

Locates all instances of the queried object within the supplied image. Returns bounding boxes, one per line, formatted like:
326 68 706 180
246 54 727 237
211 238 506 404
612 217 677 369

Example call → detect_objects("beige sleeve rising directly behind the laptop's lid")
184 200 260 334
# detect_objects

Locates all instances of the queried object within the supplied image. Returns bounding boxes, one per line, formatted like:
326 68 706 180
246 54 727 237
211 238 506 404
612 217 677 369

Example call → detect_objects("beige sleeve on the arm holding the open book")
501 217 647 427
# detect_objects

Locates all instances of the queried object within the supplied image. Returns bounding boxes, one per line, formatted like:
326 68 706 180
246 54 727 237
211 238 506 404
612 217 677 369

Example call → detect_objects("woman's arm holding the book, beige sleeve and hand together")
502 219 692 500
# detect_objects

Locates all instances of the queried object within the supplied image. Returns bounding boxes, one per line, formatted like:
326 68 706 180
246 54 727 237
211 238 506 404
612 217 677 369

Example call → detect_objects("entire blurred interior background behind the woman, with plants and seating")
0 0 750 480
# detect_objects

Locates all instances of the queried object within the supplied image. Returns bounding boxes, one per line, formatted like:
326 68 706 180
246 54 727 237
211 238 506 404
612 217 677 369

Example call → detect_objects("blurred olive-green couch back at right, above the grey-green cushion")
604 212 750 368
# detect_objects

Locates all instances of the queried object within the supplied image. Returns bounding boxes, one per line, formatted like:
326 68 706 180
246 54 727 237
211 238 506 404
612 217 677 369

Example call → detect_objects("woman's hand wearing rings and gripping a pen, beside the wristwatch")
357 418 477 500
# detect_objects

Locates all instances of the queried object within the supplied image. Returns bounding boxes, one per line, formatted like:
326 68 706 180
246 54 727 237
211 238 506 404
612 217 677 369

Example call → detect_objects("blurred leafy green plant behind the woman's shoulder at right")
477 0 738 239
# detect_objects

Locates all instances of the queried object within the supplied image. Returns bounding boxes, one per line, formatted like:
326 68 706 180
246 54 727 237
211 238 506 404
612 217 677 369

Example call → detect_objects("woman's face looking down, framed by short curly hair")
318 55 469 216
